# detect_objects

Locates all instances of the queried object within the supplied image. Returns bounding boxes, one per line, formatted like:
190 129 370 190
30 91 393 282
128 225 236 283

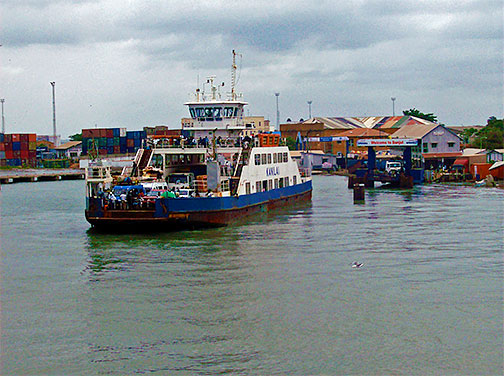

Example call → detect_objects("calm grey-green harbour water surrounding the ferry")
0 176 504 375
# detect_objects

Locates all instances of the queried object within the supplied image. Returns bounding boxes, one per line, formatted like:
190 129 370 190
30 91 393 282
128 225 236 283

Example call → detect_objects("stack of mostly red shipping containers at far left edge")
0 133 37 167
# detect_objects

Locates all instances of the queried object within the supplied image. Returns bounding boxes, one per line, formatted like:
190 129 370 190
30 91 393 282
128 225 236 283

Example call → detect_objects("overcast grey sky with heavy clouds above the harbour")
0 0 504 138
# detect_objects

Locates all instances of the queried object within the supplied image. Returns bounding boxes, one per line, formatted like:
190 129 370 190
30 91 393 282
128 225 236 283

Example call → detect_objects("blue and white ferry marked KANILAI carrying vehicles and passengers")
85 51 312 231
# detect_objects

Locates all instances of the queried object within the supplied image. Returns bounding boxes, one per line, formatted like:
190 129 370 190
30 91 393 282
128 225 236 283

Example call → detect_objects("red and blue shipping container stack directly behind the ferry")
82 128 146 155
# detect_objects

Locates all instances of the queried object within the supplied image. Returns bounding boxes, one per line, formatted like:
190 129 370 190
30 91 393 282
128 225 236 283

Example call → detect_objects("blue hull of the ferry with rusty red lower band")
86 181 312 231
